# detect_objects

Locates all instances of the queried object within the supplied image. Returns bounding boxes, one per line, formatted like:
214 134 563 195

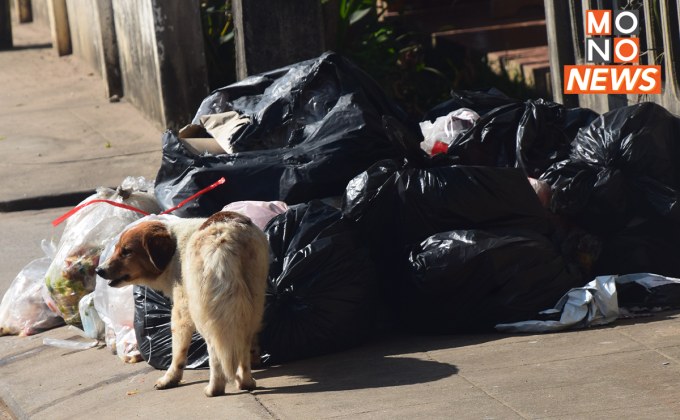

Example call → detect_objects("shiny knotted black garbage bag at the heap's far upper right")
541 103 680 235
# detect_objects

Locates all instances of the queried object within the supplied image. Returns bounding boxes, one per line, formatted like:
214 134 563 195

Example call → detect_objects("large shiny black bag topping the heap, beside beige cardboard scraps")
155 53 419 217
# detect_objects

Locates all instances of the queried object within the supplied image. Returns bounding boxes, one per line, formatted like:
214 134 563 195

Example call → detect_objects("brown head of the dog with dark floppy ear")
95 221 177 289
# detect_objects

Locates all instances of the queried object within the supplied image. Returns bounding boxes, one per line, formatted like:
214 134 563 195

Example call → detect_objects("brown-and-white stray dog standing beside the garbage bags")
96 211 269 397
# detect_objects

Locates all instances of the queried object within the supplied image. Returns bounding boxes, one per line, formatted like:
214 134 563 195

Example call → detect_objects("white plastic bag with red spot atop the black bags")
420 108 479 155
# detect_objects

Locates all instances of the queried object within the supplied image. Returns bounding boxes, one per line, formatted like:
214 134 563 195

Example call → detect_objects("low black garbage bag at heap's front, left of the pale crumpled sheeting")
401 230 584 333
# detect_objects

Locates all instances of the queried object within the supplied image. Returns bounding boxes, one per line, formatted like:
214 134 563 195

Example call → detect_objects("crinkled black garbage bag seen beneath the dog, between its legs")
134 286 209 369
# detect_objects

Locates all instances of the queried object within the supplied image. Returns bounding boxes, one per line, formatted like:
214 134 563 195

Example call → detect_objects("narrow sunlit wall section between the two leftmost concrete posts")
65 0 103 76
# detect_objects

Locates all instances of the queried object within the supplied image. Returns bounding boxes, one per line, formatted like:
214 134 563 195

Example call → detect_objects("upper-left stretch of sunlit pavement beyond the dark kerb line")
0 18 162 211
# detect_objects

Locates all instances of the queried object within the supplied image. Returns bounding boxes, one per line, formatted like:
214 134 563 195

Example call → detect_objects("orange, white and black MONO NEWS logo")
564 10 661 94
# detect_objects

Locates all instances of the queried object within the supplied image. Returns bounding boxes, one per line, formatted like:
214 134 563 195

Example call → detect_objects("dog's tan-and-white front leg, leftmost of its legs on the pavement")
155 285 196 389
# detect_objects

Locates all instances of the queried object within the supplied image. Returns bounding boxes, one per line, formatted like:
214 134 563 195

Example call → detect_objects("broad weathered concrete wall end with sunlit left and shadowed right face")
112 0 208 129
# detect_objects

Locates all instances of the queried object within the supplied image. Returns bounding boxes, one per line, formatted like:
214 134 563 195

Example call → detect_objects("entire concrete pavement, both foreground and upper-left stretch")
0 18 680 419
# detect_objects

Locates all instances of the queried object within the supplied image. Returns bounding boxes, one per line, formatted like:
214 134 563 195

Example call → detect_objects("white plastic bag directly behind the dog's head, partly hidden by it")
93 215 177 363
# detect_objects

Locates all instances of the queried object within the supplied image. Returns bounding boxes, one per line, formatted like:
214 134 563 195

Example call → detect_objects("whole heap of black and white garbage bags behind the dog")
0 53 680 368
